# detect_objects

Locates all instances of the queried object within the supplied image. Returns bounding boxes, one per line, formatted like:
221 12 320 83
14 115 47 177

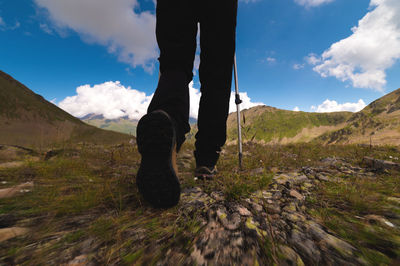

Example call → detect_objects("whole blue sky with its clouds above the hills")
0 0 400 118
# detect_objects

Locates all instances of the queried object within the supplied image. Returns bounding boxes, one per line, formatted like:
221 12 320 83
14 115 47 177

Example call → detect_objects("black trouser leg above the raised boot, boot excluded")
147 0 197 150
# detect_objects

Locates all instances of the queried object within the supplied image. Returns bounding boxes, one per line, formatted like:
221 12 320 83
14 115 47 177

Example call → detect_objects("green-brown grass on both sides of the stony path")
0 142 400 265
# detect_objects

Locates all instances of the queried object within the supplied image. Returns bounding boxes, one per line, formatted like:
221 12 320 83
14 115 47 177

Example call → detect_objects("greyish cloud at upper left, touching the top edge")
35 0 158 71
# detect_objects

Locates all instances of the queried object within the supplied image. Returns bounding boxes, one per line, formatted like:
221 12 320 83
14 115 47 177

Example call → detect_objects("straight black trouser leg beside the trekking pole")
195 0 237 167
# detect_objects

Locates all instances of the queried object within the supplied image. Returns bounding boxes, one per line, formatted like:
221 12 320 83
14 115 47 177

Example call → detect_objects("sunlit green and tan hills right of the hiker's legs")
228 89 400 145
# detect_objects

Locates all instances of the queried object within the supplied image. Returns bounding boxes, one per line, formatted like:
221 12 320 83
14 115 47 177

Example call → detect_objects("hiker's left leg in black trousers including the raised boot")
136 0 197 208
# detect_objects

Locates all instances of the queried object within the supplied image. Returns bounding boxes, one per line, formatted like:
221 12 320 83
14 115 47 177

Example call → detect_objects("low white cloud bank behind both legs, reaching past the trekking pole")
57 81 264 120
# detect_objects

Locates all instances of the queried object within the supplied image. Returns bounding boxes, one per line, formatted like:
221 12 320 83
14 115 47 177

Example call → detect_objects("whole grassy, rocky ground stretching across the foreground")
0 142 400 265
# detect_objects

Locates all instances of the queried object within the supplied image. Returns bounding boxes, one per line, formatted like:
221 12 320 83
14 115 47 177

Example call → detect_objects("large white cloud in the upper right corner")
314 0 400 91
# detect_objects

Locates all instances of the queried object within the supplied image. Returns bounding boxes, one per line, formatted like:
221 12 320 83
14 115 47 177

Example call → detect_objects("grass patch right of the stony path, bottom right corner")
308 166 400 265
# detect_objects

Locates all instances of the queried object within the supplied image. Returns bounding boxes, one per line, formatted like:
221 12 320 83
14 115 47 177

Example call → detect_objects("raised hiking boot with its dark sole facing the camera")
136 110 181 208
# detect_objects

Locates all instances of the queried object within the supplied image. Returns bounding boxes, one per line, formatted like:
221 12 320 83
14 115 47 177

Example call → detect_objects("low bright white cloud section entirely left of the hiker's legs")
58 81 153 119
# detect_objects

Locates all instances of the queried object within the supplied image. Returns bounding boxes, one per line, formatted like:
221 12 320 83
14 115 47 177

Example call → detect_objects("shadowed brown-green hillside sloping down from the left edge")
0 71 130 147
